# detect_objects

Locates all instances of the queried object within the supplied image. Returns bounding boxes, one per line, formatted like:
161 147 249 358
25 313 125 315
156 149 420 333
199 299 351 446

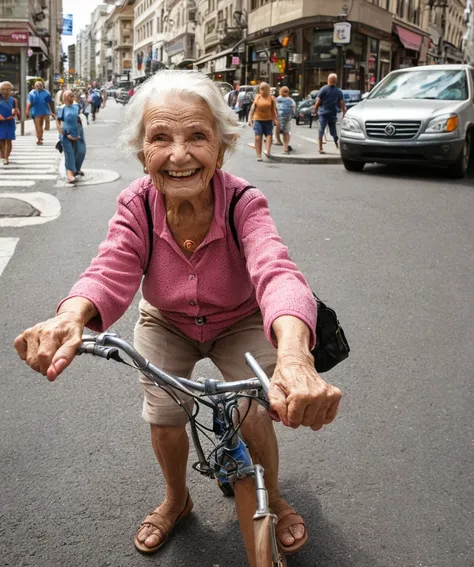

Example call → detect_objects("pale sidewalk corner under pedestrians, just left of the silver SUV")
241 121 342 165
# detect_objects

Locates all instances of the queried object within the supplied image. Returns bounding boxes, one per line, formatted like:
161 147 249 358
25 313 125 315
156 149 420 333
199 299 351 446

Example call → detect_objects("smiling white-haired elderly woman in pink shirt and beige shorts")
15 71 341 566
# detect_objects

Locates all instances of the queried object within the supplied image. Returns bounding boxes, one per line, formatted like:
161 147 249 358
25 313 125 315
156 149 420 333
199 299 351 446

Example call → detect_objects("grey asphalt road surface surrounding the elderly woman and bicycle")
0 101 474 567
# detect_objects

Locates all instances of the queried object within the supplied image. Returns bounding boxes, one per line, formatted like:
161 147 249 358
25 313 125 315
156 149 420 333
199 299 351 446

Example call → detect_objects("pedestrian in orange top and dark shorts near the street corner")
249 83 278 161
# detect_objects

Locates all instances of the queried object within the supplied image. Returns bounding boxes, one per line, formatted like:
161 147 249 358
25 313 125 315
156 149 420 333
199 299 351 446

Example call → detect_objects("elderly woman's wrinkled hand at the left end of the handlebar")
14 312 85 382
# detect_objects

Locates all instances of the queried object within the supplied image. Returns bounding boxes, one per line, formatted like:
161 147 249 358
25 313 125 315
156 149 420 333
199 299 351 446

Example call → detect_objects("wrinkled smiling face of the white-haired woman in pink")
142 95 222 201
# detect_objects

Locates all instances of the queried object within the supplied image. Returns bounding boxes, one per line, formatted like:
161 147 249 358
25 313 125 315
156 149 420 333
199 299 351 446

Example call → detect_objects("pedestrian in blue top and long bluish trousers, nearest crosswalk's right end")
56 90 86 183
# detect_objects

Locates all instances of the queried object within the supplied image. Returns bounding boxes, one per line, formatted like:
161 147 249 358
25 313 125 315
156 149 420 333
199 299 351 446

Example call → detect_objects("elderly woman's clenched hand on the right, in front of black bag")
269 355 342 431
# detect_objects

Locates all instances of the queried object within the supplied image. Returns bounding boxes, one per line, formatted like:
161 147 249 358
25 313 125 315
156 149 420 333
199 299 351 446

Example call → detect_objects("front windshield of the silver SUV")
369 69 469 100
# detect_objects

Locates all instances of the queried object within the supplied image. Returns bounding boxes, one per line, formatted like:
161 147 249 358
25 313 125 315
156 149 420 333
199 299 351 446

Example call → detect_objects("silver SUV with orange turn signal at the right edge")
340 65 474 178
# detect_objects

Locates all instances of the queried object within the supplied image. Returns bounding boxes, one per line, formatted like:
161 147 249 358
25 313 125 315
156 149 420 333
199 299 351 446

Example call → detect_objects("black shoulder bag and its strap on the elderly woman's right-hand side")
229 185 351 373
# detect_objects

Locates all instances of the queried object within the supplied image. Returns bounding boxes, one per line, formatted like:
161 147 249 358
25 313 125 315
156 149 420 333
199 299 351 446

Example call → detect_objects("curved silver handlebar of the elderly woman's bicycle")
77 333 270 398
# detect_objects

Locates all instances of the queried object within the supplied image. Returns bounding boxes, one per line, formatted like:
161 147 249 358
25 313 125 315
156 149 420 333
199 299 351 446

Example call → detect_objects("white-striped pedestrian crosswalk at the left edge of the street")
0 130 61 188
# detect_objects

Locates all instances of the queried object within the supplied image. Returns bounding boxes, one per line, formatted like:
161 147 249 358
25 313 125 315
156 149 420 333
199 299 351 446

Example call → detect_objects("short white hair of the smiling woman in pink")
119 70 238 160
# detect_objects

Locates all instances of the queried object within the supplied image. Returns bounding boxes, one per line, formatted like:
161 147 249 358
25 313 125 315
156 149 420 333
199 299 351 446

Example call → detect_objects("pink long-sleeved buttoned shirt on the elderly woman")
61 170 316 348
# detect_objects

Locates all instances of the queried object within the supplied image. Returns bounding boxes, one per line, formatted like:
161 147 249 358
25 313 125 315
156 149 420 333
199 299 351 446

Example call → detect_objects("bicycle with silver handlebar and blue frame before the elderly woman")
77 333 286 567
